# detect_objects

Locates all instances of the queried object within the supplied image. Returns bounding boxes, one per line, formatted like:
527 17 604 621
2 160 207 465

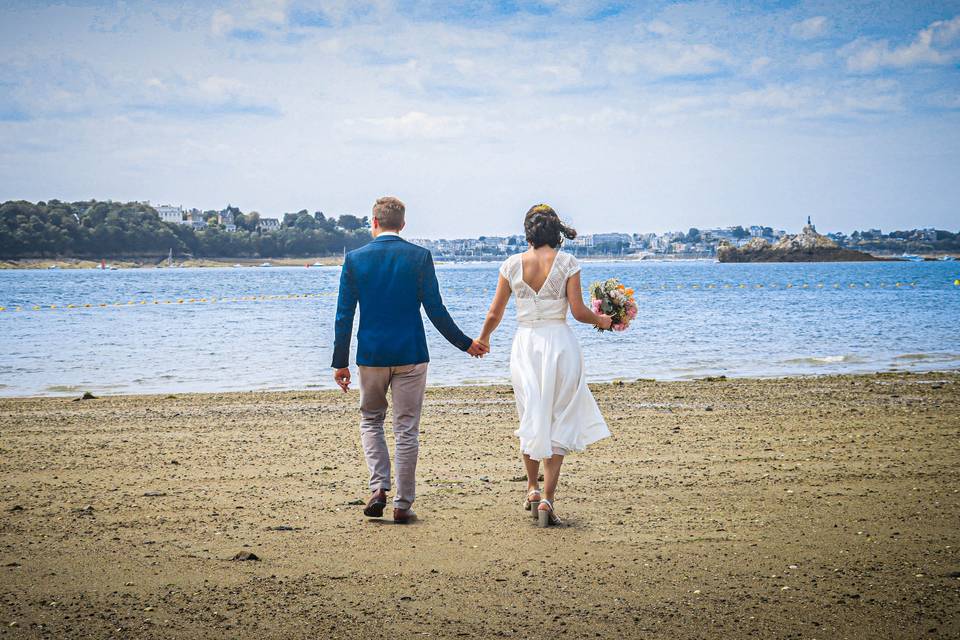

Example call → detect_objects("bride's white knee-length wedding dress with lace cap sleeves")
500 251 610 460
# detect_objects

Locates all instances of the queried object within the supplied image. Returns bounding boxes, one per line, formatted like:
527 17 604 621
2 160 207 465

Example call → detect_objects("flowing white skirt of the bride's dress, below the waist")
510 320 610 460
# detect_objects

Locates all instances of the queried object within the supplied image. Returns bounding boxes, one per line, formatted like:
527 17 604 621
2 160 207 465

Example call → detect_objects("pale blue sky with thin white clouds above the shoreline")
0 0 960 237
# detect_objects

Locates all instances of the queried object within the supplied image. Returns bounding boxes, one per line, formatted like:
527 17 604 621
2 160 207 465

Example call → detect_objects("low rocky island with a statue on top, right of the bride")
717 218 889 262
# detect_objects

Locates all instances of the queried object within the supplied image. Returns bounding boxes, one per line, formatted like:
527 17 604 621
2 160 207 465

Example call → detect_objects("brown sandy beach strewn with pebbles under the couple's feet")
0 373 960 638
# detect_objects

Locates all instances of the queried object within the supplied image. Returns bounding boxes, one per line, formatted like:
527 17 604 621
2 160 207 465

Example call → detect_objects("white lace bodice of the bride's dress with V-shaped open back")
500 251 580 326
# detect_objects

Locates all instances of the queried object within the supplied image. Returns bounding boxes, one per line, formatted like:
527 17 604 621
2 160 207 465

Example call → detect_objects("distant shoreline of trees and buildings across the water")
0 200 960 263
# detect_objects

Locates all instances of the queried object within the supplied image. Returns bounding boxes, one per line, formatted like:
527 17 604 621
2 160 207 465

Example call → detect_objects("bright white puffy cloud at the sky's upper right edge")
840 16 960 72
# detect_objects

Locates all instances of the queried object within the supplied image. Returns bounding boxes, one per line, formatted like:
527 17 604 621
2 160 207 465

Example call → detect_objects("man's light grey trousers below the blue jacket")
357 362 427 509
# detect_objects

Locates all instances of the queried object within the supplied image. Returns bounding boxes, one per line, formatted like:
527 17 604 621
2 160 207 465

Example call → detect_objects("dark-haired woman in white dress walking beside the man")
477 204 612 527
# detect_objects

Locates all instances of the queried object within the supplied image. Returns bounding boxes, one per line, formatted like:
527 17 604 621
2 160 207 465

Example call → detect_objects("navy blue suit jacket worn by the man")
332 235 473 369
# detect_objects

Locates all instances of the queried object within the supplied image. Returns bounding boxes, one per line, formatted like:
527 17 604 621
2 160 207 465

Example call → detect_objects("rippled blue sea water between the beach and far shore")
0 261 960 396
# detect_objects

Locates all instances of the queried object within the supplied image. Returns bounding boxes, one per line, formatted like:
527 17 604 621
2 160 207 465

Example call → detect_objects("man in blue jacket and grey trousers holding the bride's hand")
333 197 489 524
